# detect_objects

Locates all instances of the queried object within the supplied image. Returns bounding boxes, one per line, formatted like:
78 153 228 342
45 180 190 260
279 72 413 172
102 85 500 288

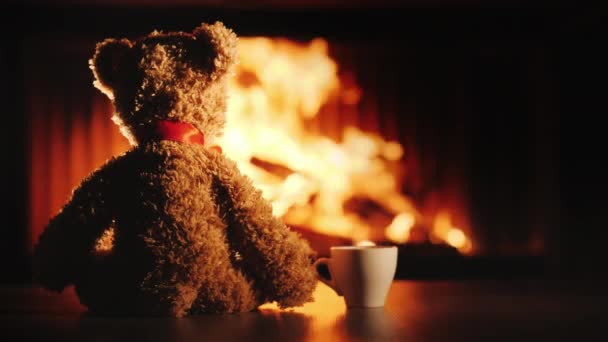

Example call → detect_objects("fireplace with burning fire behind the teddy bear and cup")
3 5 584 276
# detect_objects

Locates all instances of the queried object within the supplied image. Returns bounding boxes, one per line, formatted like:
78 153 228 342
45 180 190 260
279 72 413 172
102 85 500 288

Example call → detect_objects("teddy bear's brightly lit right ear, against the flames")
192 21 238 77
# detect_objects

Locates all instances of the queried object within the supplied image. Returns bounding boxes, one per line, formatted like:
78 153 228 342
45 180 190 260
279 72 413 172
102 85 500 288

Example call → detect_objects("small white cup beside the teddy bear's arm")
315 246 397 308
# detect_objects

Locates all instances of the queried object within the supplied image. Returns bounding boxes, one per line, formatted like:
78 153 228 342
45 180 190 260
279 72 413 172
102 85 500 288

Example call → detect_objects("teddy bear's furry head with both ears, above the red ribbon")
89 22 237 144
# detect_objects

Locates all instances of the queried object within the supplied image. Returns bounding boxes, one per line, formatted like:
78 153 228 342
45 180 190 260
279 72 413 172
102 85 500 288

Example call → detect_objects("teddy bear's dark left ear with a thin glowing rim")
89 39 133 98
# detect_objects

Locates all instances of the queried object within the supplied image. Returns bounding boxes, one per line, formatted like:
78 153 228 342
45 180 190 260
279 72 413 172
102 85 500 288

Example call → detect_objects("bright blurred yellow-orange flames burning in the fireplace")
220 37 471 251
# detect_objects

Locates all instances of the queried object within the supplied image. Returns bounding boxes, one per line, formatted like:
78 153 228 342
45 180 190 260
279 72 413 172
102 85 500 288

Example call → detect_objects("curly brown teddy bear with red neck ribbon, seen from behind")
33 22 316 317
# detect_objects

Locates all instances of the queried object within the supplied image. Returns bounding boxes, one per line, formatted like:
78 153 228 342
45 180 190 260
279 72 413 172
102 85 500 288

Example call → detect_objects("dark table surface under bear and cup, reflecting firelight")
0 280 608 341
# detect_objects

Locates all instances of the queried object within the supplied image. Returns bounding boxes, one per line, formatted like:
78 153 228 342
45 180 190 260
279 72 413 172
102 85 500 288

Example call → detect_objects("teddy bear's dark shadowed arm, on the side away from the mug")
33 165 112 291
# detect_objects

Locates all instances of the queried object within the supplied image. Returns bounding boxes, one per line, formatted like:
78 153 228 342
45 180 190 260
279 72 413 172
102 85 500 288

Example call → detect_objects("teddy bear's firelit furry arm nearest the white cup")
214 154 316 307
